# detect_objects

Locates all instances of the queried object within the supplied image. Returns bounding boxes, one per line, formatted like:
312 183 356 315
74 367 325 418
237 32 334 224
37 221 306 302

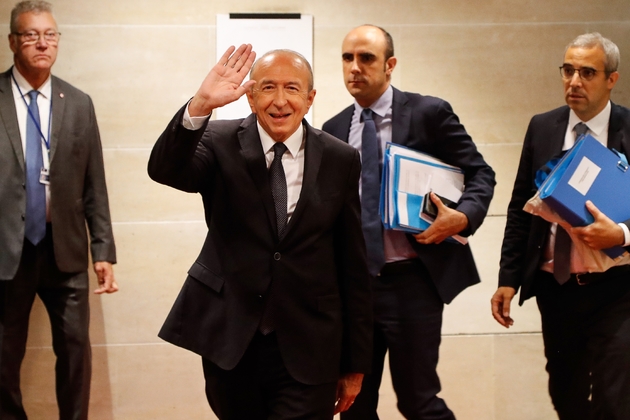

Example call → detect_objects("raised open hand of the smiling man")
188 44 256 117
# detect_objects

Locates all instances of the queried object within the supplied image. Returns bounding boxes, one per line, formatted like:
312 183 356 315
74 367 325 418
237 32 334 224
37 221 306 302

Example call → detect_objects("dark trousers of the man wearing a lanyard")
0 229 91 420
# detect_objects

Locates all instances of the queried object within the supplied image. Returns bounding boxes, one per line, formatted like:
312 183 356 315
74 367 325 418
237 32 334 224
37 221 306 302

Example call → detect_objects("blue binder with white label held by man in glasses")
539 135 630 258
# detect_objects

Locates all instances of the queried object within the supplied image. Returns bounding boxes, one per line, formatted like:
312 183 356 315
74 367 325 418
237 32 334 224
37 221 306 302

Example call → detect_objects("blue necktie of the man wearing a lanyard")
25 90 46 245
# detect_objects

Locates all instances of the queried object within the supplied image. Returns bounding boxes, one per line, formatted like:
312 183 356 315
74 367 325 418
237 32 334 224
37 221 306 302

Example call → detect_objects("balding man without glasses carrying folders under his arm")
323 25 495 420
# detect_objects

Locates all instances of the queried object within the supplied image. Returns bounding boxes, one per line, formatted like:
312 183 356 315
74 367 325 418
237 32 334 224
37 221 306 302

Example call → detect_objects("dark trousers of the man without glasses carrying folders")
341 260 455 420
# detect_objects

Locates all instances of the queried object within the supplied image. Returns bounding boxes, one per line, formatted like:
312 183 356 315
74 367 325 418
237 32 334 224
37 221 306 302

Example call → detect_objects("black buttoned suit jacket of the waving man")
148 108 372 384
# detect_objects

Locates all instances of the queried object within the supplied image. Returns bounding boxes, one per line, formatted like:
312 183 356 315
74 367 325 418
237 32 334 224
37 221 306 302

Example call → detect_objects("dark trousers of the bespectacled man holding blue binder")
536 271 630 420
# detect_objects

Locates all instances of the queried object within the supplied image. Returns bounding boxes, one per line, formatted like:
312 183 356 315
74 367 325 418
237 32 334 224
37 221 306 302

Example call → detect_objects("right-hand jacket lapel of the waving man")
285 121 324 238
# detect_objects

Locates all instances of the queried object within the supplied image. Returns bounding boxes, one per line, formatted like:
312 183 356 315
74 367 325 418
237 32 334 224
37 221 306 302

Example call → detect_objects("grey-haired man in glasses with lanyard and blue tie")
0 1 118 420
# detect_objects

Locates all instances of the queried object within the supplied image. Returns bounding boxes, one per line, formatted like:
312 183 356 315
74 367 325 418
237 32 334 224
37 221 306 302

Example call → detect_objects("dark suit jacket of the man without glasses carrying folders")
322 88 495 303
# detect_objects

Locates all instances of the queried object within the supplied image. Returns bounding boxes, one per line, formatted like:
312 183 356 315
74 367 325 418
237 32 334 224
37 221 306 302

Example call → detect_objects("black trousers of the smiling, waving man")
202 333 337 420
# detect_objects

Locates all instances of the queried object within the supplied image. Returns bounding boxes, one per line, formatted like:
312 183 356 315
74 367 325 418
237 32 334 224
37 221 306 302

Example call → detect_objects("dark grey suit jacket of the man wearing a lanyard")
0 69 116 280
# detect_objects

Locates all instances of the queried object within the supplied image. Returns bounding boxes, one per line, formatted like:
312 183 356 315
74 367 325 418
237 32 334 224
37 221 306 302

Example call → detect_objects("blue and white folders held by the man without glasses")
380 143 467 244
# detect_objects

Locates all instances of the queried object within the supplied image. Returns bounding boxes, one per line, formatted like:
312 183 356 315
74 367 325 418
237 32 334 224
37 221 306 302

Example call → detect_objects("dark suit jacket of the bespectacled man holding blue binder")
499 104 630 304
